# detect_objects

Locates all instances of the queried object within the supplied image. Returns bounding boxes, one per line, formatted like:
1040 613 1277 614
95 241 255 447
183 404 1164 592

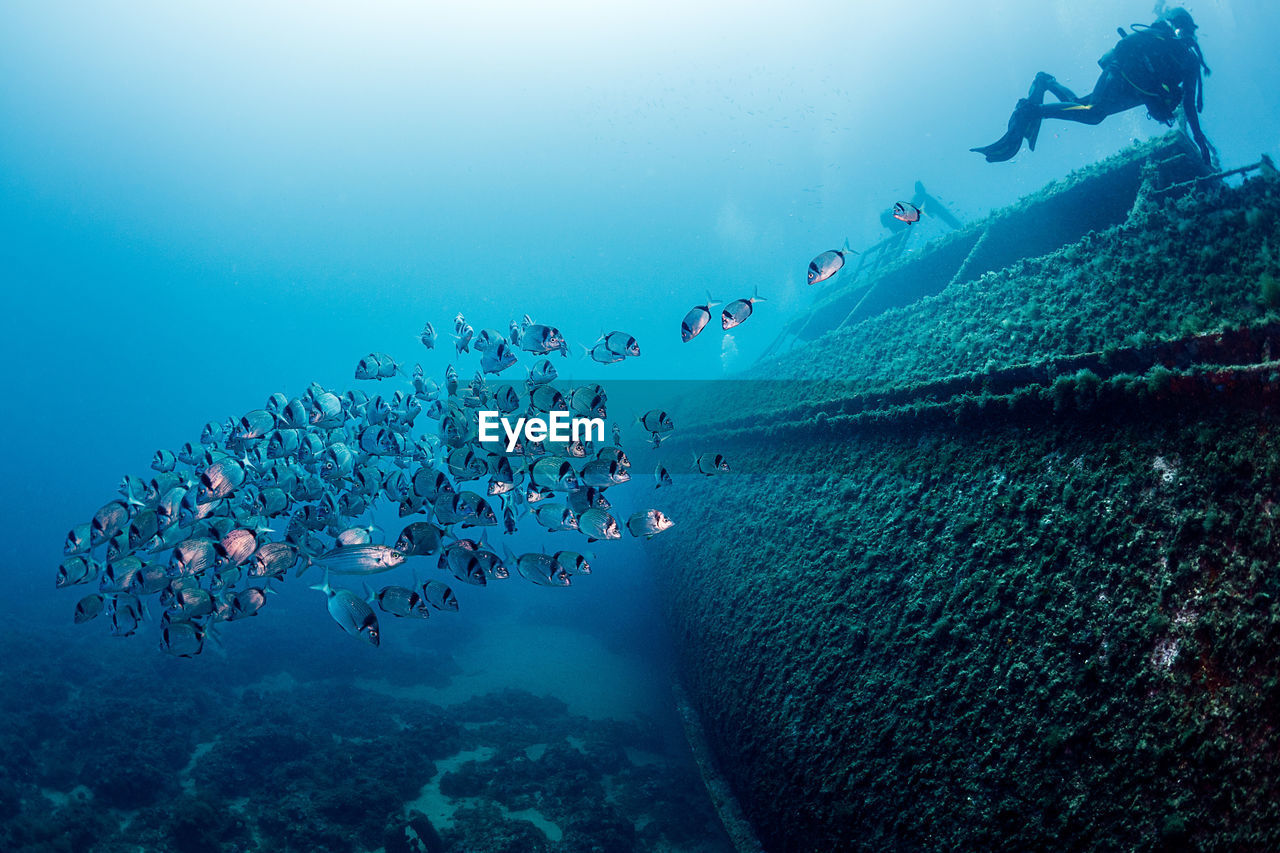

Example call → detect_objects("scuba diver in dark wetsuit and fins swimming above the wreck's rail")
969 6 1213 164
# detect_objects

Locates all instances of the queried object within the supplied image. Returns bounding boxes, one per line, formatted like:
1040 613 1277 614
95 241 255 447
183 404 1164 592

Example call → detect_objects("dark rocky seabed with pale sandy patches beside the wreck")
0 634 730 853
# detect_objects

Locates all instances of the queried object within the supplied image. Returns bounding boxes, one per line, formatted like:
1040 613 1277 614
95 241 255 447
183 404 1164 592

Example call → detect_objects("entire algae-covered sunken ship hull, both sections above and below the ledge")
654 136 1280 850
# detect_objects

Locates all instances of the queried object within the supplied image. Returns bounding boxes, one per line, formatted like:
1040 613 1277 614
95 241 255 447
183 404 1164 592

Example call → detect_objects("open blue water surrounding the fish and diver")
0 0 1280 845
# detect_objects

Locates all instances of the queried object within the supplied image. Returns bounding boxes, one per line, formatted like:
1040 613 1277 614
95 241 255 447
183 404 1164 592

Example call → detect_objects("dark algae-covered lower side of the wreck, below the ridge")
657 412 1280 850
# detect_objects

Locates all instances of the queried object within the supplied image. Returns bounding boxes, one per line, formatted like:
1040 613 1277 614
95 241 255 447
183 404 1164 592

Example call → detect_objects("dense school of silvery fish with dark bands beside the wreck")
56 312 721 657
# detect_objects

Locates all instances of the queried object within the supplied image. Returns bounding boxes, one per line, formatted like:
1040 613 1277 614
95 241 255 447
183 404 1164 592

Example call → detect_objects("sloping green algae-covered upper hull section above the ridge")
744 165 1280 412
